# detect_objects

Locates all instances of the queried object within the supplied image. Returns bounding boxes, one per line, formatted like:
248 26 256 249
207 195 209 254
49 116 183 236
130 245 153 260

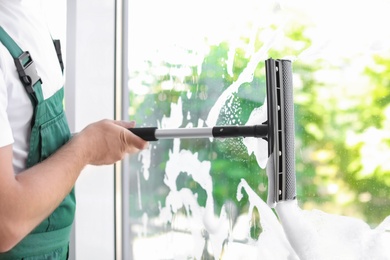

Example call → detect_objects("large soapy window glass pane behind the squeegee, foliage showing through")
128 0 390 259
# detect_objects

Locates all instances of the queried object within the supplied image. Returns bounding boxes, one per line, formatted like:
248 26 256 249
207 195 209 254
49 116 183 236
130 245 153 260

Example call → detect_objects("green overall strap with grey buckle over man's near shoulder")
0 26 43 104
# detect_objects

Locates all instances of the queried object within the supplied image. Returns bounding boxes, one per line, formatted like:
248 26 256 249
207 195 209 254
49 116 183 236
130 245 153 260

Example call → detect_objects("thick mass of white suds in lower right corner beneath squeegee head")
276 201 390 260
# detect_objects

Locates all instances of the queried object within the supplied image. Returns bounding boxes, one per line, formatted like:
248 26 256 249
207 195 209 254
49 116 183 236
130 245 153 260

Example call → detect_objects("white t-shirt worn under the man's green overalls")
0 0 64 174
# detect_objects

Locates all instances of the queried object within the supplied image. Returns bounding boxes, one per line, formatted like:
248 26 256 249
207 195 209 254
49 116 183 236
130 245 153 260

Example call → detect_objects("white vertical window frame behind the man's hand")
65 0 125 259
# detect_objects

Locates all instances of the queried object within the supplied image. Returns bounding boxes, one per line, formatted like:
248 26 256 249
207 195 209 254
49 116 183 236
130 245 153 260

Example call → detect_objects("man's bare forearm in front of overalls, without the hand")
0 138 88 252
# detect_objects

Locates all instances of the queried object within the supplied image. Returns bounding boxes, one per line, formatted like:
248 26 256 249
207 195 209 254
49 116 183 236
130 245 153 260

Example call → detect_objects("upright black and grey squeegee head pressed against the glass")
265 59 296 207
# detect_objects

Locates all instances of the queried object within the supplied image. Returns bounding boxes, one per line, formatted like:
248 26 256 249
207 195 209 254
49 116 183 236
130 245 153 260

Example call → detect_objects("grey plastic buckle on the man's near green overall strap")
14 51 42 94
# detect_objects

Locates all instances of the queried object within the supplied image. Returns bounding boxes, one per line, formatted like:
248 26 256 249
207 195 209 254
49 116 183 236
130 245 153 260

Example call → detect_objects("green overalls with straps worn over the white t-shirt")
0 26 76 260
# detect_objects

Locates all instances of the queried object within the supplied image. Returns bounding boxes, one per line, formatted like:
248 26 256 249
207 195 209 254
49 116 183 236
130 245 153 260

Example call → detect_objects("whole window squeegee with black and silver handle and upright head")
129 59 296 207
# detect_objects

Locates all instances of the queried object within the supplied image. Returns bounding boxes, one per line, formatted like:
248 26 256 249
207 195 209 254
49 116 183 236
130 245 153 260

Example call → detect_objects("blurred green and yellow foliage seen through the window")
129 26 390 224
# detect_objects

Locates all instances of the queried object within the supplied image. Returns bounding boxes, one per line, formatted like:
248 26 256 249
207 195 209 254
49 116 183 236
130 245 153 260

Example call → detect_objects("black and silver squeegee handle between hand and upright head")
129 124 268 141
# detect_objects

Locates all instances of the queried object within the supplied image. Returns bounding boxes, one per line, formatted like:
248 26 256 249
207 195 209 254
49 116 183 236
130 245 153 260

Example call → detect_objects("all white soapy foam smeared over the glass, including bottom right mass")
135 54 390 260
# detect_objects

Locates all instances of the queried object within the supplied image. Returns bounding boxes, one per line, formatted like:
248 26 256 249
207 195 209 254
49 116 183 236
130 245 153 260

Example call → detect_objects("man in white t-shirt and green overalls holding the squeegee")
0 0 147 259
